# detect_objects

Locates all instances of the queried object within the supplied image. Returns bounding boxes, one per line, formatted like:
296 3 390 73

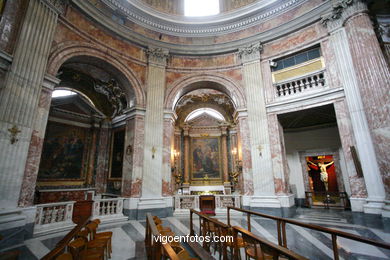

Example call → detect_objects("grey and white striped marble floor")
4 208 390 260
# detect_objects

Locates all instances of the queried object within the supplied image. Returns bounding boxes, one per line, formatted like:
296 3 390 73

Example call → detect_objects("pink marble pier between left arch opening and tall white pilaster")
122 114 145 197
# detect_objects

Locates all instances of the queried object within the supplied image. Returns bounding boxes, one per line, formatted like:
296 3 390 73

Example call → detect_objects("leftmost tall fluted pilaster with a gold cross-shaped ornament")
0 0 59 208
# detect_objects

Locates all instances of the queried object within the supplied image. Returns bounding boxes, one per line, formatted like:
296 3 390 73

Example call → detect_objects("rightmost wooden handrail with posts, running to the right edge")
227 206 390 260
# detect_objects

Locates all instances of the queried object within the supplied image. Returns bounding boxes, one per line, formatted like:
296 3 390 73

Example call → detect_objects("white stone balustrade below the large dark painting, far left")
34 201 75 234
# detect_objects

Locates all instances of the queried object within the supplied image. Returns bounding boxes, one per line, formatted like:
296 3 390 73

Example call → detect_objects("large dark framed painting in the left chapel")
38 121 87 180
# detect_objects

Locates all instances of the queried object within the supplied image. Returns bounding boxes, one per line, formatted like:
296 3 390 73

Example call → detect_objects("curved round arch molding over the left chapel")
47 41 146 107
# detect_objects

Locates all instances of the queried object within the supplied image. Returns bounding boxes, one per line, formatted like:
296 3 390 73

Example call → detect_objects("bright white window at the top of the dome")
184 0 219 16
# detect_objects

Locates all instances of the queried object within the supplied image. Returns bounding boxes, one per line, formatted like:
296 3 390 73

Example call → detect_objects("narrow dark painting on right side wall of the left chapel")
109 128 126 180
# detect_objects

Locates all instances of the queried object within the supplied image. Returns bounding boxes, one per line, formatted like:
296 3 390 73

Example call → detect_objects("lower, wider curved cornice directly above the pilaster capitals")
72 0 331 55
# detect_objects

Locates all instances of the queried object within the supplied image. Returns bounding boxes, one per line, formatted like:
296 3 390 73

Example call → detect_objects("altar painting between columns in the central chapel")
191 137 221 180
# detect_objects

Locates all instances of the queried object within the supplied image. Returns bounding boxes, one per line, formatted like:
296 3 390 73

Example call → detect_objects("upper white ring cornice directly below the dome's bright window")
101 0 308 37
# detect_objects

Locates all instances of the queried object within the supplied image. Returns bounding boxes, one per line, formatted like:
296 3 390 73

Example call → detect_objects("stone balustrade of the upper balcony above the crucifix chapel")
274 70 325 97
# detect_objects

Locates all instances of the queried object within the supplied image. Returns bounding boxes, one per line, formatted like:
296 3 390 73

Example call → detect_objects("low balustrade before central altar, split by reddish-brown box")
174 195 241 214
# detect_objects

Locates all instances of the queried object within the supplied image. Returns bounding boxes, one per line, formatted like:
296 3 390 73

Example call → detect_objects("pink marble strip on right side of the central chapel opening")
238 114 253 196
